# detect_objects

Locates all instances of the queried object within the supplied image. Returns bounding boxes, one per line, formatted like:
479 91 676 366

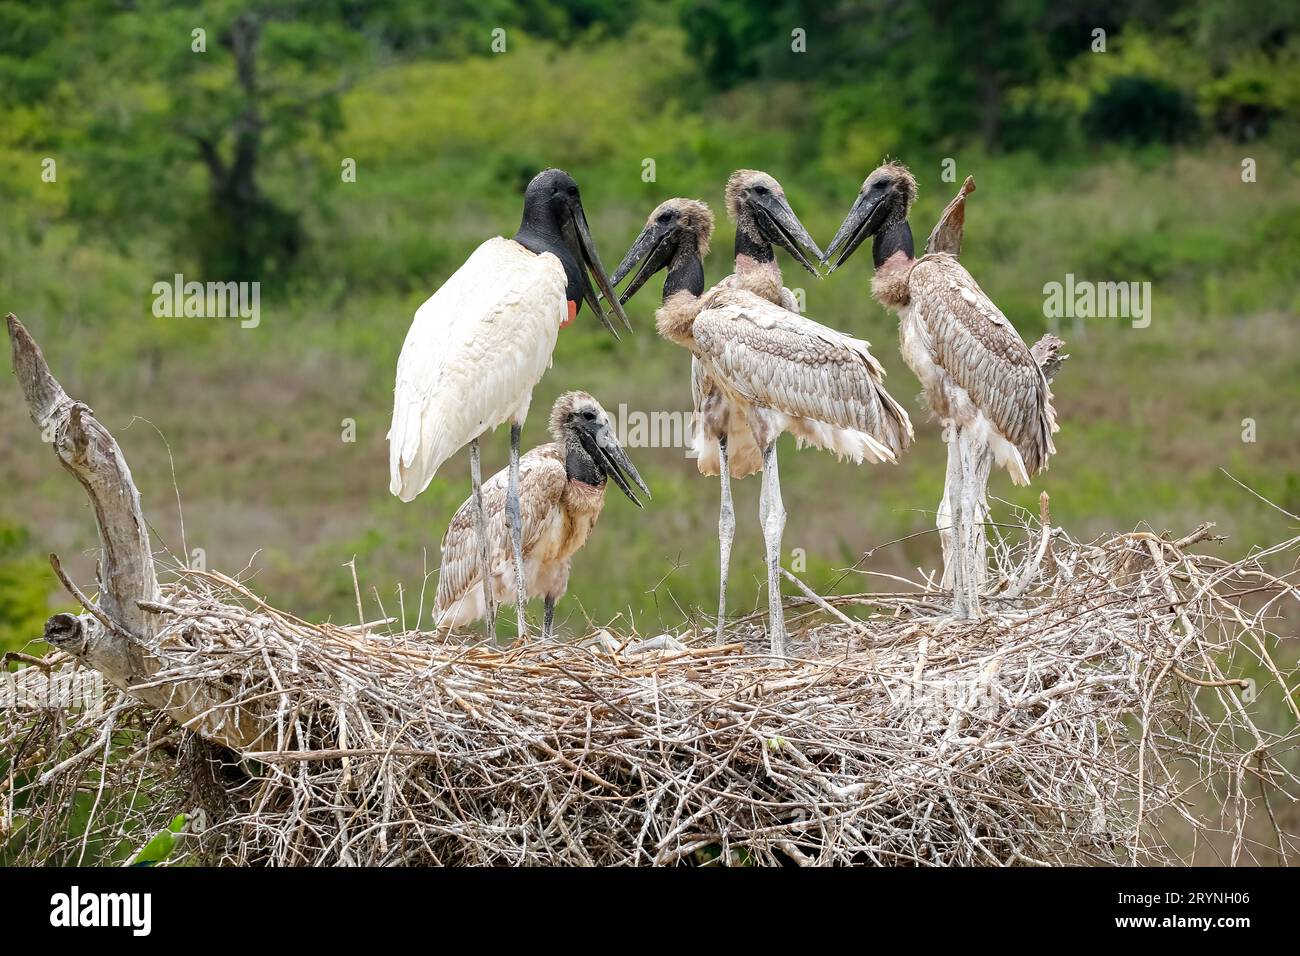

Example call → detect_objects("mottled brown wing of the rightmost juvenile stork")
909 255 1057 475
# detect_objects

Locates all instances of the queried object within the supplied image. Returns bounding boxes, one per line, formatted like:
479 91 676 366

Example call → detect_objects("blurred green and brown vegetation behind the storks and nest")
0 0 1300 665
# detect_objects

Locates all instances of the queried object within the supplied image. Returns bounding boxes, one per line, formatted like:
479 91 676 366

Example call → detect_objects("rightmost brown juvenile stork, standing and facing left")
823 163 1058 617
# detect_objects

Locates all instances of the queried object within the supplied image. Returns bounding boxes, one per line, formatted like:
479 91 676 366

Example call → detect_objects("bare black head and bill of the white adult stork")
515 169 632 338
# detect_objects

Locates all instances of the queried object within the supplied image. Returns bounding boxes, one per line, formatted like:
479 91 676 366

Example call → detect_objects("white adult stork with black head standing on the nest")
389 169 631 640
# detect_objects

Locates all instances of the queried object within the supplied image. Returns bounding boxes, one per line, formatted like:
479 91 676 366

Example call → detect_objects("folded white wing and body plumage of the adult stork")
389 238 568 501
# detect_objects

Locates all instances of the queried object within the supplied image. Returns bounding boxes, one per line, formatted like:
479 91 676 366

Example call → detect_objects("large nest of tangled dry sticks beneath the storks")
0 527 1300 866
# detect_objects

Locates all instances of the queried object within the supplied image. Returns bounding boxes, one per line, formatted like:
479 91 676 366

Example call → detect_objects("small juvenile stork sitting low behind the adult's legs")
437 392 650 639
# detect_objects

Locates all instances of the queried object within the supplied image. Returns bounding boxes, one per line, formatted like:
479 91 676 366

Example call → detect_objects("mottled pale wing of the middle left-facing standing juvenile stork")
693 291 911 454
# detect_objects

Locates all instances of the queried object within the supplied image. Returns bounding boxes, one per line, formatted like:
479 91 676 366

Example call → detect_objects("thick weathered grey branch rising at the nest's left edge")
8 313 265 749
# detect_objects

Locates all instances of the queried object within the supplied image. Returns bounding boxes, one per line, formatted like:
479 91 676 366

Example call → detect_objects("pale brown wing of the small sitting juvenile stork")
438 445 568 609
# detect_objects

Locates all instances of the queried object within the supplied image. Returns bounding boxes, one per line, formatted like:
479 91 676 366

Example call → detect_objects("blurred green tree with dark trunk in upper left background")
0 0 367 280
